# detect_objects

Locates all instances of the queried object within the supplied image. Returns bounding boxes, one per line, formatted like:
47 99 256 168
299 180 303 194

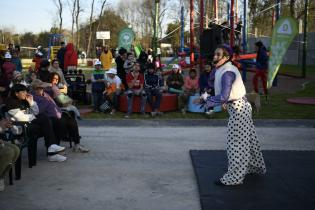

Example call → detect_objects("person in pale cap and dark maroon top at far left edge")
0 52 16 98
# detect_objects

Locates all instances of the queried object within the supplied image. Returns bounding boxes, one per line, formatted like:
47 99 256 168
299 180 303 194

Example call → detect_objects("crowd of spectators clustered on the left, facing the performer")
0 43 89 191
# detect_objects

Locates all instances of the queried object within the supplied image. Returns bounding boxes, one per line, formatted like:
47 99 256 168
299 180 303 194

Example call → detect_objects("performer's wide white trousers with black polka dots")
220 99 266 185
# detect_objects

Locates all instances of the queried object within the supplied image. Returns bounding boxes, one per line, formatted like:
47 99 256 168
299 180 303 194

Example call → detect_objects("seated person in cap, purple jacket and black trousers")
31 79 89 152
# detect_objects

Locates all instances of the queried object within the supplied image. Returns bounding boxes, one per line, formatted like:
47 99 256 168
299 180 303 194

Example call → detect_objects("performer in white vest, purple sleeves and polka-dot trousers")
199 46 266 185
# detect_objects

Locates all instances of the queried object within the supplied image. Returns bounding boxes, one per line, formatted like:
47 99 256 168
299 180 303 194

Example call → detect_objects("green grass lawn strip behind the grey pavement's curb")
84 82 315 119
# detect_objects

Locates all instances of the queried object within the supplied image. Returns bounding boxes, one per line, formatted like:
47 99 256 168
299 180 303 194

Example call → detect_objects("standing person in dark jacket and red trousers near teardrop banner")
253 41 268 95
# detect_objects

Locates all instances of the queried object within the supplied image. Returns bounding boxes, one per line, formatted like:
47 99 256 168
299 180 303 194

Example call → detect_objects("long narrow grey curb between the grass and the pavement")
78 119 315 128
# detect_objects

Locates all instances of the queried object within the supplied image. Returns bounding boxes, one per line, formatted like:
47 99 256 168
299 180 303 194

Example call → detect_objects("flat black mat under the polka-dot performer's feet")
190 150 315 210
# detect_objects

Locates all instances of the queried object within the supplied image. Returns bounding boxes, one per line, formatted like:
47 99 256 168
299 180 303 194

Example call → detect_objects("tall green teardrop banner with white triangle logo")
267 17 298 88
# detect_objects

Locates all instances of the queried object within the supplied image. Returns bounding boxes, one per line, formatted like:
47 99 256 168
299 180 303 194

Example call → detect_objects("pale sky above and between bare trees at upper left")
0 0 118 33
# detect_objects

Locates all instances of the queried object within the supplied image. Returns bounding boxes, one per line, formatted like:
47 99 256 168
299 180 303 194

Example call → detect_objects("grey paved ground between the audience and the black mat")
0 120 315 210
